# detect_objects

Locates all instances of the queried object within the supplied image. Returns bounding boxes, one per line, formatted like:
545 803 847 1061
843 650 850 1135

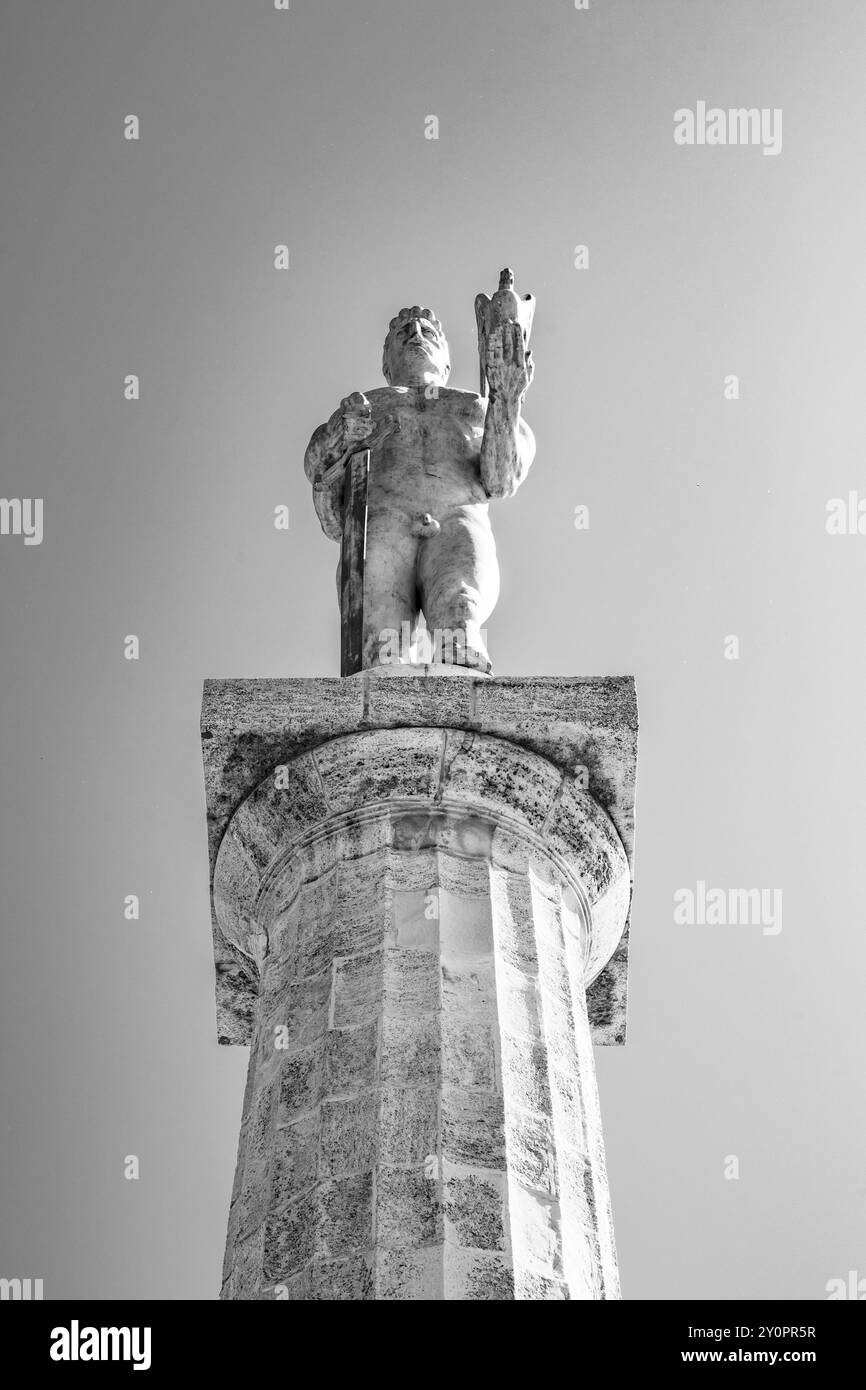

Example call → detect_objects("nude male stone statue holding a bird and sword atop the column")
304 271 535 674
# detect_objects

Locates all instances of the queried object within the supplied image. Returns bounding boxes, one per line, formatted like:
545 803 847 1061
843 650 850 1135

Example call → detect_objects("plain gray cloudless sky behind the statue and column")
0 0 866 1298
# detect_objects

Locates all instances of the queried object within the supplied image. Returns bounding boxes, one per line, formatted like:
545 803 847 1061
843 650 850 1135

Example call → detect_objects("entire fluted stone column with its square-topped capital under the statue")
203 676 637 1300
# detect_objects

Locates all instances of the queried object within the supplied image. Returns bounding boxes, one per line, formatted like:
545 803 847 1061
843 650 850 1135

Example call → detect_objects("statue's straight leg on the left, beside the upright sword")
363 512 420 669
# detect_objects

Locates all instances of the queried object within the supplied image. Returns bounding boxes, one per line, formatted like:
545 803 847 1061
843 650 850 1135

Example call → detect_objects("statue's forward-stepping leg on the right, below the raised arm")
418 503 499 671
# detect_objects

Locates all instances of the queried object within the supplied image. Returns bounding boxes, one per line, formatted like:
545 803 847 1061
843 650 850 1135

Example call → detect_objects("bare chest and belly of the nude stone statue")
367 386 488 516
